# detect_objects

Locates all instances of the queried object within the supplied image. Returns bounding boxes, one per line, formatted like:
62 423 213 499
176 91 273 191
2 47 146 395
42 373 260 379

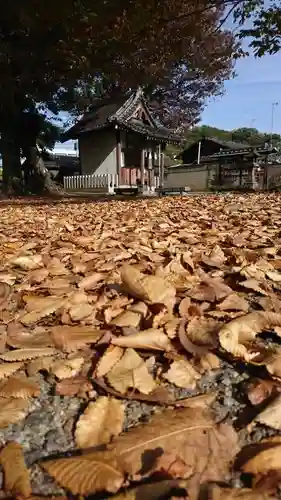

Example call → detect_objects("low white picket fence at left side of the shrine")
63 174 118 194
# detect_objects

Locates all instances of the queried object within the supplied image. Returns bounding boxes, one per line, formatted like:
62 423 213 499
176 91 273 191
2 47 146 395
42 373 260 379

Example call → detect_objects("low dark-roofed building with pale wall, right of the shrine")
165 139 277 191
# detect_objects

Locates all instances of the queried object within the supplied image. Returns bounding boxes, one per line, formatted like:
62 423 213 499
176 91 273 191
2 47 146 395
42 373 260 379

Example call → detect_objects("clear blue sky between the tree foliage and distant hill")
201 53 281 133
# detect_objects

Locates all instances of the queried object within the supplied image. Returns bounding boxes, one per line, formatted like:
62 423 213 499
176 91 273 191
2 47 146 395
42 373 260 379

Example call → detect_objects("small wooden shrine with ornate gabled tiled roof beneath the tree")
61 89 183 187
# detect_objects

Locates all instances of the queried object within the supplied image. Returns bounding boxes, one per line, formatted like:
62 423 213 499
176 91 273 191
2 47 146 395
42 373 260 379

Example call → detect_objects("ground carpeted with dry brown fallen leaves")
0 194 281 500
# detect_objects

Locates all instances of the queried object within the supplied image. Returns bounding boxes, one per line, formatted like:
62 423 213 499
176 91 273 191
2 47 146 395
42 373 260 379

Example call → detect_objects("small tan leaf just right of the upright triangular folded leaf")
163 360 201 389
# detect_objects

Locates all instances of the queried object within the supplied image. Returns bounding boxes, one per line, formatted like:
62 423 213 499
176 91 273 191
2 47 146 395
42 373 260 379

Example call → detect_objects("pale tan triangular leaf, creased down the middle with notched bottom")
107 349 156 394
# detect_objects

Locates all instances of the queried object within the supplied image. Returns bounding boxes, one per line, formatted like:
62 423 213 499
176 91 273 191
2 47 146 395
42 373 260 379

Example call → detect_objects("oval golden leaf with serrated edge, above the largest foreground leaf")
75 396 125 448
